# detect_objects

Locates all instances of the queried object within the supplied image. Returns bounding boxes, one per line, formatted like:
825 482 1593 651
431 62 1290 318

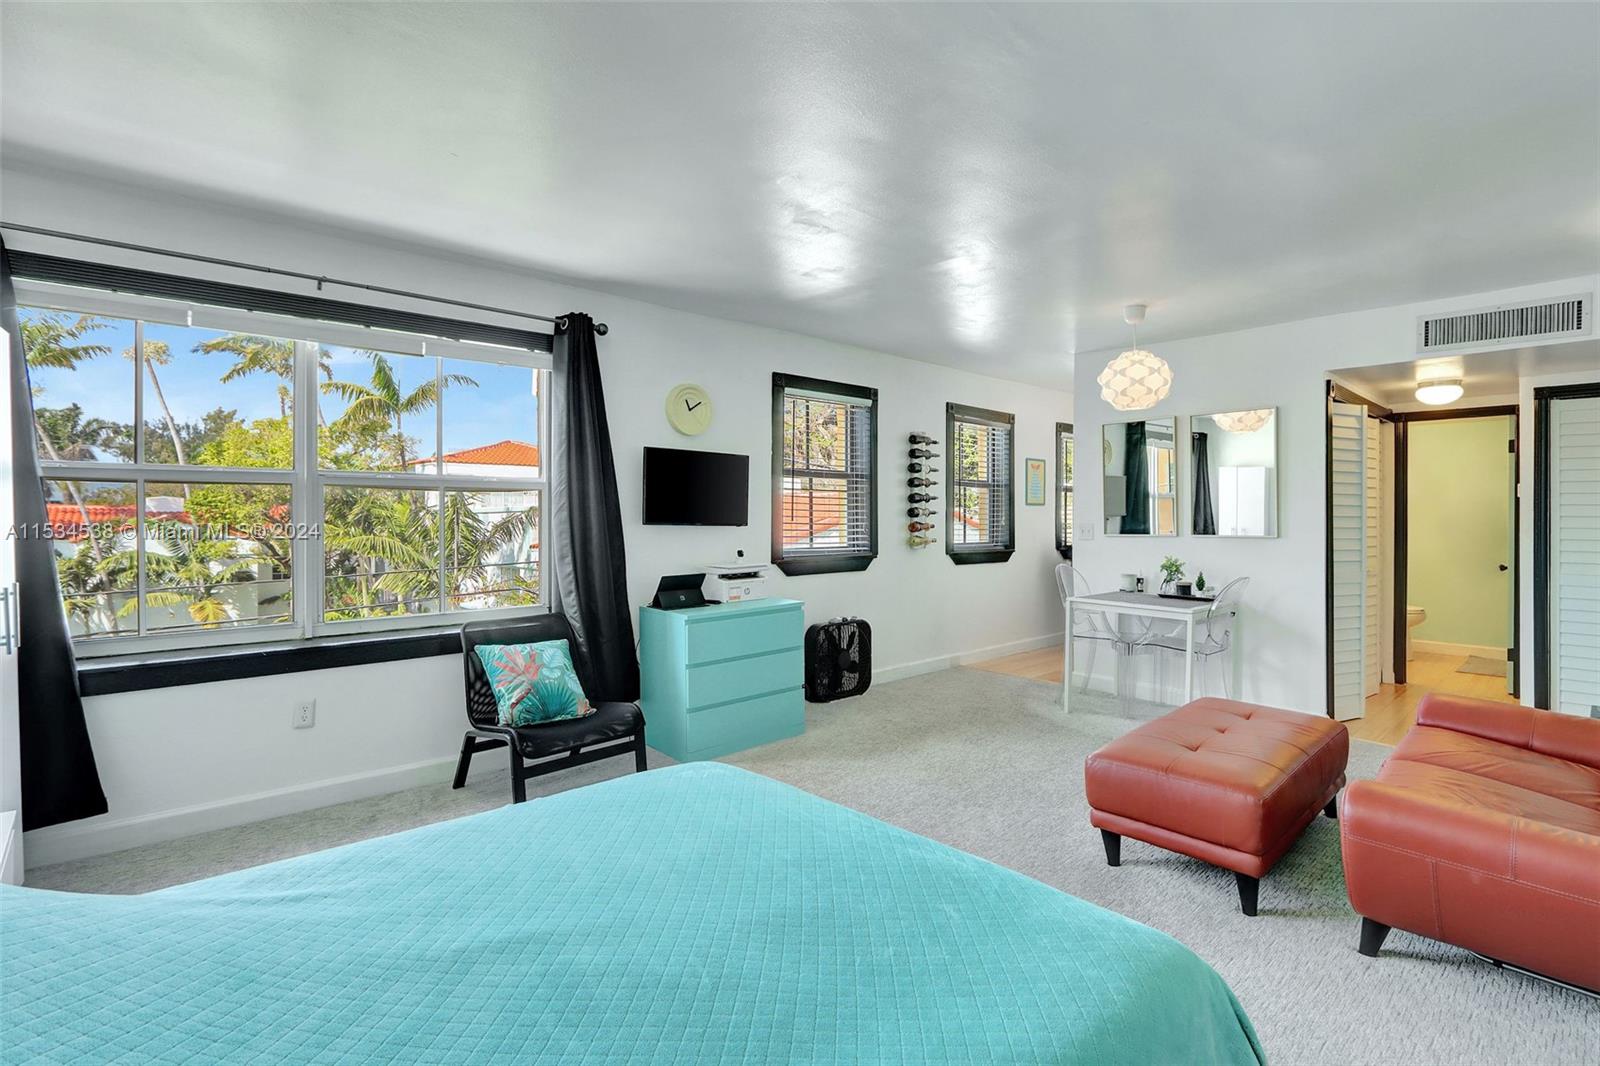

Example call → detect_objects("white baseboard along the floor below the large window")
22 755 456 869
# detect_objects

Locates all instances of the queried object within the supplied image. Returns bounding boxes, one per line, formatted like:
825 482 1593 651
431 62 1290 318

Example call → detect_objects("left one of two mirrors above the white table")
1101 418 1178 536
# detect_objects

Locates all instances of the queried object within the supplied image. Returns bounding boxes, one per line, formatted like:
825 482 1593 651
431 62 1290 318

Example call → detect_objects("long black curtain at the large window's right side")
550 314 638 701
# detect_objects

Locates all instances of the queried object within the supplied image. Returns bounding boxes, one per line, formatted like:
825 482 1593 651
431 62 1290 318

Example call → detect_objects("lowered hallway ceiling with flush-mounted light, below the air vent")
1333 341 1600 410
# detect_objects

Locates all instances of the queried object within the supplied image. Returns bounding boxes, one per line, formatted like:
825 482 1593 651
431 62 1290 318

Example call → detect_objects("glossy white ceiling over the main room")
0 2 1600 384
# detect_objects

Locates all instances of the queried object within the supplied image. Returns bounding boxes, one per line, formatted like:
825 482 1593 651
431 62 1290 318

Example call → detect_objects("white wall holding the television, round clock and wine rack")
0 164 1072 864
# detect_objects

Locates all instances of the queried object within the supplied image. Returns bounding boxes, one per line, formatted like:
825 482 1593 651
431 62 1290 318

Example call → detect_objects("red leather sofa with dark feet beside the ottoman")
1339 693 1600 989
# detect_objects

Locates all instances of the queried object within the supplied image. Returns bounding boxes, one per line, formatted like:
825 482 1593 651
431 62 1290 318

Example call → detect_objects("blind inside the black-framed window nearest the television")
779 387 875 559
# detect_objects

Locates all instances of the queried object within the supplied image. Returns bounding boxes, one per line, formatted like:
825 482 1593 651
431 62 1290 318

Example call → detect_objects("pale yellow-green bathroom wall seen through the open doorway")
1406 415 1514 648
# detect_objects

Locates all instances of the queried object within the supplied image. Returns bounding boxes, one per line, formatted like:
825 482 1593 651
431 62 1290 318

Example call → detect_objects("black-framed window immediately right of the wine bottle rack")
944 403 1016 563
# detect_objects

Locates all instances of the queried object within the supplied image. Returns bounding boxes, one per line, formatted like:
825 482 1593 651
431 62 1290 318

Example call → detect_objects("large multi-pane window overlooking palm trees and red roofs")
19 283 547 655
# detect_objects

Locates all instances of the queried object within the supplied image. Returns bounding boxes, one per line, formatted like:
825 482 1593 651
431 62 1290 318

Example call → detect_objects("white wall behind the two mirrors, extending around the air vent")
1074 275 1600 714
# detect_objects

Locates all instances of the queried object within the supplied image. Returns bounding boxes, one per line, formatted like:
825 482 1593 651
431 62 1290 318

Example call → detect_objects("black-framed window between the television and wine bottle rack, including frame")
773 375 878 575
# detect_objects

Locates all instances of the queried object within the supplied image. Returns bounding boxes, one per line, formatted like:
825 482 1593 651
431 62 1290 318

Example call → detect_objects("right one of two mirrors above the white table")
1189 407 1278 536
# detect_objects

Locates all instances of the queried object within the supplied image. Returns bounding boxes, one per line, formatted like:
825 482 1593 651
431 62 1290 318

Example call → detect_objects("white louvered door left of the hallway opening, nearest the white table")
1328 403 1366 720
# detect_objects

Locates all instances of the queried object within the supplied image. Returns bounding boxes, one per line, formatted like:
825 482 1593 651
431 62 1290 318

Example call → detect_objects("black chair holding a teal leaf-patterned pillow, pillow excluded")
451 613 646 804
